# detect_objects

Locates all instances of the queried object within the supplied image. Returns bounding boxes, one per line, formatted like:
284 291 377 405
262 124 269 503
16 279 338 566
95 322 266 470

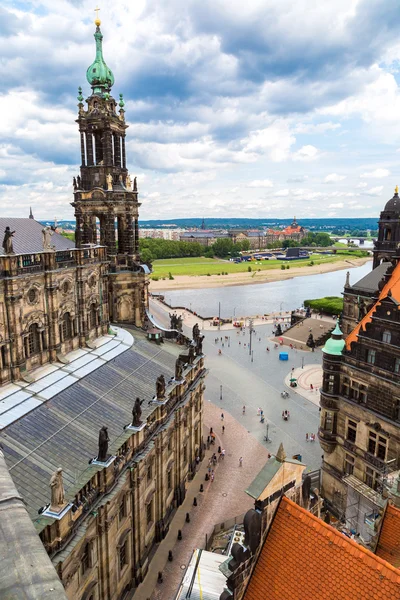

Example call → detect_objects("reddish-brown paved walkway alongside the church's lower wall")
134 400 268 600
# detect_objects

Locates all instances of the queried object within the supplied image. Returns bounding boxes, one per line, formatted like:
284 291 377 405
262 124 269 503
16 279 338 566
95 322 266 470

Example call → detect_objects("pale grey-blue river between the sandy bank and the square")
157 261 372 318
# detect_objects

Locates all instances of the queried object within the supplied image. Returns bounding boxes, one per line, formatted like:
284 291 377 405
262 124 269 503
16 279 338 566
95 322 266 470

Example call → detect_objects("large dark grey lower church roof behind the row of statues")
0 332 179 520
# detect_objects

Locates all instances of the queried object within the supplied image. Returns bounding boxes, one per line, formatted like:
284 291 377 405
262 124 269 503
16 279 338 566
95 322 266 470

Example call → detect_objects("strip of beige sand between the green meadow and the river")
150 256 371 292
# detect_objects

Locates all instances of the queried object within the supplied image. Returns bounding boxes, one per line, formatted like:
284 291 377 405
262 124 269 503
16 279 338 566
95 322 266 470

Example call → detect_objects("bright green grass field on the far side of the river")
152 254 362 279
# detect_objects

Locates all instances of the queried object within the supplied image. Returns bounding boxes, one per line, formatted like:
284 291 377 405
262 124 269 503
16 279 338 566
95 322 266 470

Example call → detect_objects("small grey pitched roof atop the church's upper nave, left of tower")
0 217 75 255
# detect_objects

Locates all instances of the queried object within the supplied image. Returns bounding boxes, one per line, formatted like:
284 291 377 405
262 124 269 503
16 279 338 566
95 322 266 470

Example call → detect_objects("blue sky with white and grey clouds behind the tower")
0 0 400 219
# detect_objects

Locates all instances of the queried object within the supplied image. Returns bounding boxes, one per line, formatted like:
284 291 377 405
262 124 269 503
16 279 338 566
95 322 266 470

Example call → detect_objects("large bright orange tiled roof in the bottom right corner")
244 497 400 600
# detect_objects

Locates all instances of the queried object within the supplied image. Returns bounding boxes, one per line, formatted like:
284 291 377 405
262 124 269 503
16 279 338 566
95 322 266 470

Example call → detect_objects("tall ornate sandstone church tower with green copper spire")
72 18 149 327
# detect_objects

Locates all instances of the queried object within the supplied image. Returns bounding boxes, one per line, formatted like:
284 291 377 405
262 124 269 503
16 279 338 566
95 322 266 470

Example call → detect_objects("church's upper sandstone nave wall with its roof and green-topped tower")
0 16 149 385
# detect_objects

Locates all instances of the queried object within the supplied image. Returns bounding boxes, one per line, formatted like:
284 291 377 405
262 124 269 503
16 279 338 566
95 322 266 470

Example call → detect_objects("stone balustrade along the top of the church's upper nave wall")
0 246 107 277
